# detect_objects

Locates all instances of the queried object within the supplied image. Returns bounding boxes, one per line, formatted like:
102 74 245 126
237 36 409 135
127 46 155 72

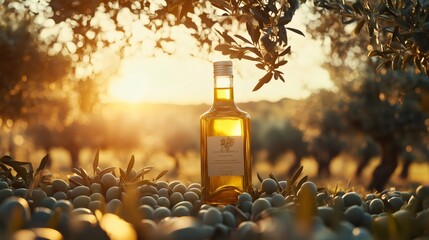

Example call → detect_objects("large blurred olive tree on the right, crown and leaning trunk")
307 0 428 190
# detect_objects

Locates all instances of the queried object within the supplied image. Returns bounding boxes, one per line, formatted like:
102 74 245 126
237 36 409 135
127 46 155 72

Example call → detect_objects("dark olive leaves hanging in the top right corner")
315 0 429 76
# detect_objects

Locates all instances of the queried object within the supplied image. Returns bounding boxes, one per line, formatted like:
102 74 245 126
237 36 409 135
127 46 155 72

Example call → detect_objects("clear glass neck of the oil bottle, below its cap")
213 76 234 106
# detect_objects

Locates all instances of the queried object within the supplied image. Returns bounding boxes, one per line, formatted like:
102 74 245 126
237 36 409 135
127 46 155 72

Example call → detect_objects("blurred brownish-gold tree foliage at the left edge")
0 5 70 121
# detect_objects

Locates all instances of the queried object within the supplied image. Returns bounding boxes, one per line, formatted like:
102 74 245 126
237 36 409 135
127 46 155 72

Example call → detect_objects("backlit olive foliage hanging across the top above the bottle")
36 0 304 91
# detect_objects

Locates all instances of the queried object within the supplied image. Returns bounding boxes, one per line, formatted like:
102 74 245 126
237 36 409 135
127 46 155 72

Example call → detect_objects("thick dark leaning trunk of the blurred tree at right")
368 141 399 192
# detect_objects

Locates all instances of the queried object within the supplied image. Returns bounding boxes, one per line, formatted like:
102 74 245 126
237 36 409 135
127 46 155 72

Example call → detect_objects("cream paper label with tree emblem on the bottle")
207 136 244 176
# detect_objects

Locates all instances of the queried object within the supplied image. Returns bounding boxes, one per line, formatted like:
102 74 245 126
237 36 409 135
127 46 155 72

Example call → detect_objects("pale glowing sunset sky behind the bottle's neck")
106 8 333 104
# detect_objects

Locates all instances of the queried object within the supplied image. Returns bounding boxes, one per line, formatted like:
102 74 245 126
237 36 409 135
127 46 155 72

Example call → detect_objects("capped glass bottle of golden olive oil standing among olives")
200 61 252 205
